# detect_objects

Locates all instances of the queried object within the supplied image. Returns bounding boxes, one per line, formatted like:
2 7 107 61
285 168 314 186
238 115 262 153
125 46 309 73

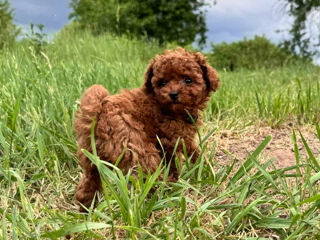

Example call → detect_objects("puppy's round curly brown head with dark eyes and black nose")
144 48 219 112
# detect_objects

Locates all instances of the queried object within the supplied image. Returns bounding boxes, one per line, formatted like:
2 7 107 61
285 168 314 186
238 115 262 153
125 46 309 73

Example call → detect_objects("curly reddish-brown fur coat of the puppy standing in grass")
75 48 219 211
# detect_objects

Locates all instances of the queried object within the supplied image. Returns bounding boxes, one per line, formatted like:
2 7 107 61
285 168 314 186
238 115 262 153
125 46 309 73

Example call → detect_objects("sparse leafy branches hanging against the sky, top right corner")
280 0 320 58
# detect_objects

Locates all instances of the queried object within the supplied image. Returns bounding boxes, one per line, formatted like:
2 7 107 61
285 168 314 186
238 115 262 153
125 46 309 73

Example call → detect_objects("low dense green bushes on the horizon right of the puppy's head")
209 36 308 71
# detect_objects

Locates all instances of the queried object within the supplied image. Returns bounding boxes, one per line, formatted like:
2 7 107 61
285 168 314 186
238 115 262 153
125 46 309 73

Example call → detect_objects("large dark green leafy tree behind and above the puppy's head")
69 0 207 45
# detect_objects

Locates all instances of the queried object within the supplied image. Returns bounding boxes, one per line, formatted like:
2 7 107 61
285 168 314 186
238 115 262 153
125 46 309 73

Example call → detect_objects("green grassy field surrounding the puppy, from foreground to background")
0 33 320 239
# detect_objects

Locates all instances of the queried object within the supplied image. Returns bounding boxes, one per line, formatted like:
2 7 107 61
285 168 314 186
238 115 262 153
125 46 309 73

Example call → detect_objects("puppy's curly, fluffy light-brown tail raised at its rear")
75 84 109 140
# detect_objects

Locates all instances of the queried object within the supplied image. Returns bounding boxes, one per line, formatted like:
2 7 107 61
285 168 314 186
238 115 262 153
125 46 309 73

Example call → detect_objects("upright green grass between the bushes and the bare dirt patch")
206 65 320 127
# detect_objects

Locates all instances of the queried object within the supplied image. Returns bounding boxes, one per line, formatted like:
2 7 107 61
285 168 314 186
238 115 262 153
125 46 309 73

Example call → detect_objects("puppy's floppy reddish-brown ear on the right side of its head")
194 52 220 92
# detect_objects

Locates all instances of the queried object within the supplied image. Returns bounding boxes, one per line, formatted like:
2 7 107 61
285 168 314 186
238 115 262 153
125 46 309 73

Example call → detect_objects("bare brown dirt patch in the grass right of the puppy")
215 125 320 168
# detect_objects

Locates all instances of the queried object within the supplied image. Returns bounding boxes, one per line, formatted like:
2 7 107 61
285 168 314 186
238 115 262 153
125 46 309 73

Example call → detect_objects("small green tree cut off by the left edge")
0 0 20 49
